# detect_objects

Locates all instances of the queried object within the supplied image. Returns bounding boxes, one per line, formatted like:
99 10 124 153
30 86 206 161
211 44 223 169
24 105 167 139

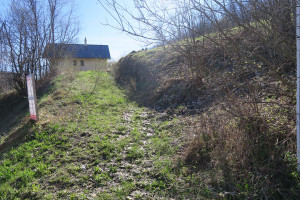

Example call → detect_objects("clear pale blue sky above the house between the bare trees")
0 0 145 61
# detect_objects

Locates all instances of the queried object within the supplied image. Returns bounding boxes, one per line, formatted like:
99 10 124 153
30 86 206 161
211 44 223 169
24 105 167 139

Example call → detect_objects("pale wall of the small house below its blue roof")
57 58 107 71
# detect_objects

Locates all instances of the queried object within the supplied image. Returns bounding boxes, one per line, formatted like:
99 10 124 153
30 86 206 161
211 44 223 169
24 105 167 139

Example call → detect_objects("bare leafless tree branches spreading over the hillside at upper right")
99 0 296 82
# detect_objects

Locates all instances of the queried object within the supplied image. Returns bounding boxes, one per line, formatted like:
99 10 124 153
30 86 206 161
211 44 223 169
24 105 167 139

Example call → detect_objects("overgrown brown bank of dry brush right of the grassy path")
115 38 300 199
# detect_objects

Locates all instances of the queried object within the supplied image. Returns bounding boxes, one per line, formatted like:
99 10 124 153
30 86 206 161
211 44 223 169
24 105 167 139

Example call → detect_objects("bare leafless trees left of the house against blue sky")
1 0 79 92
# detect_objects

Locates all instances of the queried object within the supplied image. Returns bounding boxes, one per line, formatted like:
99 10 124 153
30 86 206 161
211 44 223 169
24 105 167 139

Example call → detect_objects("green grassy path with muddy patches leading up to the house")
0 72 211 199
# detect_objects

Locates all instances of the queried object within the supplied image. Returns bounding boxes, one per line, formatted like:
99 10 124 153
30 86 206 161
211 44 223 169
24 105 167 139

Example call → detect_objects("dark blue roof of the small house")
44 44 110 59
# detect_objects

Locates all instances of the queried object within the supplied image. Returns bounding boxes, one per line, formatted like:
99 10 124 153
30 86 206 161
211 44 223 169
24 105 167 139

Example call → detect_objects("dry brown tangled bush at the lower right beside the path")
185 95 300 198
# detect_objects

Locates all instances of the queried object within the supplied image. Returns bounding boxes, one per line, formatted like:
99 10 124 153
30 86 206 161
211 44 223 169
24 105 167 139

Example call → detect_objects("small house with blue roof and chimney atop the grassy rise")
43 38 110 71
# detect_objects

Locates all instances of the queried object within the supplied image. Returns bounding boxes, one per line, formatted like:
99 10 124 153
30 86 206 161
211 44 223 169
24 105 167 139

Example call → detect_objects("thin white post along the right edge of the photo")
296 0 300 172
